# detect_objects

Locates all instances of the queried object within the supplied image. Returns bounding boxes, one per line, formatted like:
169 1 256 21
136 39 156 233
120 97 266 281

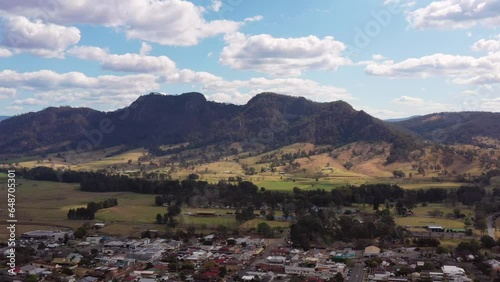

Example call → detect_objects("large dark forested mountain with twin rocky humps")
0 93 415 159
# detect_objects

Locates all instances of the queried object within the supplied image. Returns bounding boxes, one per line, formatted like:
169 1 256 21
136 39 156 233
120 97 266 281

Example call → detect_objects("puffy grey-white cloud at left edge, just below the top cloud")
2 16 80 57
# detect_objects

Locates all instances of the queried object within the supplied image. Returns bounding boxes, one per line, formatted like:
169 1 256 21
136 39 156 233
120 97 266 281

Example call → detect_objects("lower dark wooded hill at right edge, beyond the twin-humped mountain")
396 112 500 144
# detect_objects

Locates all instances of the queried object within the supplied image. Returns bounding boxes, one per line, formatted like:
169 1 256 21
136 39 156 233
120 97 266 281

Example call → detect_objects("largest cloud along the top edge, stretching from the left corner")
0 0 249 46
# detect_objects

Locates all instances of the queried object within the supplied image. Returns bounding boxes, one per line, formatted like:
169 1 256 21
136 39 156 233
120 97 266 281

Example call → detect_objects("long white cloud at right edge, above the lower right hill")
365 52 500 84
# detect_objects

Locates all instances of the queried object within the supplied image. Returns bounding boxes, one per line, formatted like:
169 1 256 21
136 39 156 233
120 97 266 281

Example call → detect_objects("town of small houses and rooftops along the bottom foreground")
1 218 500 282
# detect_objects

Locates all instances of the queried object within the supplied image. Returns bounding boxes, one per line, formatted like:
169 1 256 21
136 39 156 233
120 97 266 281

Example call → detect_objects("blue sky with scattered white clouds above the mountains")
0 0 500 119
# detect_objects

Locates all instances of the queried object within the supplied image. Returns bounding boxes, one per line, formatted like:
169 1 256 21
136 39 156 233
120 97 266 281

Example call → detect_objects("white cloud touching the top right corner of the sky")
407 0 500 29
